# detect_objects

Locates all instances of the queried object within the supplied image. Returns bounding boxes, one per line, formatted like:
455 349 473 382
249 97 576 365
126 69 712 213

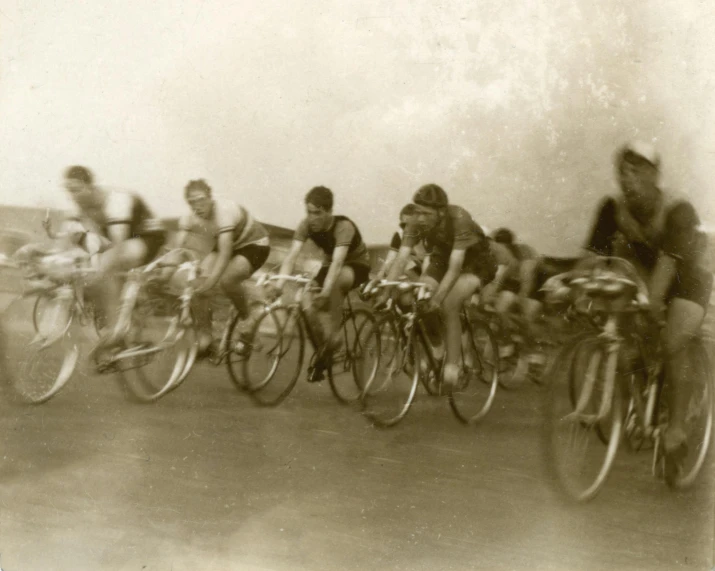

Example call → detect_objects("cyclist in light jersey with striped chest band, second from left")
176 179 271 354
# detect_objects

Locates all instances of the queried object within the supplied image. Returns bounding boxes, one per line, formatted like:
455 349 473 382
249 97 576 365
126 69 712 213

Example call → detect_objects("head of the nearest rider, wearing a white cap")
616 141 660 214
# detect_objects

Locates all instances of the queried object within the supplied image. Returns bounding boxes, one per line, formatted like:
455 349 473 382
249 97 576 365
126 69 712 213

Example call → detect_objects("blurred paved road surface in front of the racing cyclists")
0 302 715 571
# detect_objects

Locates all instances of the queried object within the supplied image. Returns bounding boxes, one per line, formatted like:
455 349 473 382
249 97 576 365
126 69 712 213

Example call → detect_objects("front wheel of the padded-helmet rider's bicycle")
360 316 422 427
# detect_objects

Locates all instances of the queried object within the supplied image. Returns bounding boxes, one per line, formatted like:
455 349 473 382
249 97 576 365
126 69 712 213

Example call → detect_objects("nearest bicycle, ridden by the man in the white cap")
544 260 713 502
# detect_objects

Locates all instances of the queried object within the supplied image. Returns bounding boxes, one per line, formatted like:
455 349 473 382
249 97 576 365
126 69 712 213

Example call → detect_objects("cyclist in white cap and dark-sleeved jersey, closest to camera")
587 142 712 478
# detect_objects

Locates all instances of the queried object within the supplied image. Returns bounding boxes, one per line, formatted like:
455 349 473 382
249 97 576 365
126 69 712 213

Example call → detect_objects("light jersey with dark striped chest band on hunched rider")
179 198 269 251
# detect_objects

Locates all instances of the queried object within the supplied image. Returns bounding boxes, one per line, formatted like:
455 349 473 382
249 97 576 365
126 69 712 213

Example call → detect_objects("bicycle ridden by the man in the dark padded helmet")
361 281 499 427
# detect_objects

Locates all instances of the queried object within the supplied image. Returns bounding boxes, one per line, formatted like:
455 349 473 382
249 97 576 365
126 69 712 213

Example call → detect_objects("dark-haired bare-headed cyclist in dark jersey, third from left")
274 186 370 382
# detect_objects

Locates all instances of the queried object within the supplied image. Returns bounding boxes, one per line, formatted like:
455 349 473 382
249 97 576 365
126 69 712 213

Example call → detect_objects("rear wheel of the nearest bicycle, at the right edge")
669 339 713 489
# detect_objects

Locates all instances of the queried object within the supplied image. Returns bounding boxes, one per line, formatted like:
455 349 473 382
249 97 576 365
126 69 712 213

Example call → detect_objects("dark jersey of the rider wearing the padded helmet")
403 204 493 263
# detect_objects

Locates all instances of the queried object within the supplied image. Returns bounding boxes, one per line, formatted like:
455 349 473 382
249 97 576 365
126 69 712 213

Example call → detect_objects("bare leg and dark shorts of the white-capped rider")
663 268 712 452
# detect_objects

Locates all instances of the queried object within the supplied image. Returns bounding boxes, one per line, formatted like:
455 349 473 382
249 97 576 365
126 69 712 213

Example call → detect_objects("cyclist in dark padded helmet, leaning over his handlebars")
388 184 497 390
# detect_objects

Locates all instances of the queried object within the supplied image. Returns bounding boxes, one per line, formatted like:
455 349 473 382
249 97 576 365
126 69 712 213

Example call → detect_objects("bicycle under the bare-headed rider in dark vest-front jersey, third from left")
243 274 380 406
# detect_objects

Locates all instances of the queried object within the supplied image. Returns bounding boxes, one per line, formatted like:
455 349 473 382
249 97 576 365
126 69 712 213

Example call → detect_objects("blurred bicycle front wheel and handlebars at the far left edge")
1 245 97 404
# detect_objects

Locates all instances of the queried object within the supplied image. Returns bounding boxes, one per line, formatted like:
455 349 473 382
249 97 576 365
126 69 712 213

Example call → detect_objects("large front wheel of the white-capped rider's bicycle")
543 335 623 502
